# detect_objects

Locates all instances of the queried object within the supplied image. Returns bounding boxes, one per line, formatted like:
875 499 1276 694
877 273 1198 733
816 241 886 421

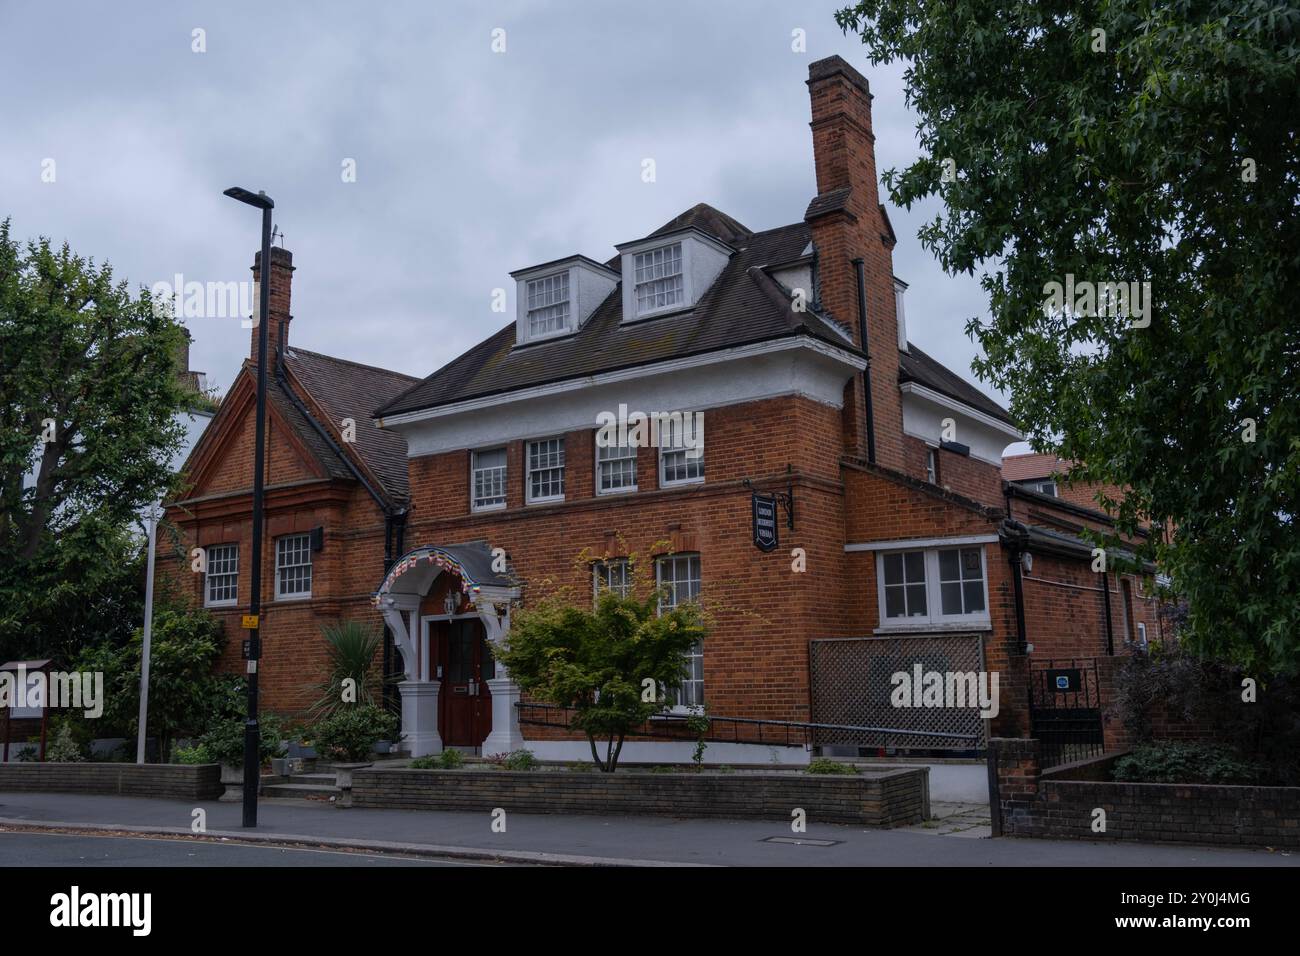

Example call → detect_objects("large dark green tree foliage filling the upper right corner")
837 0 1300 670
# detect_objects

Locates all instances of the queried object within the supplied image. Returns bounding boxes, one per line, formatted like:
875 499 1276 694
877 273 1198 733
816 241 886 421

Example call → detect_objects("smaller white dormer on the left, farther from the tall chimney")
510 256 619 345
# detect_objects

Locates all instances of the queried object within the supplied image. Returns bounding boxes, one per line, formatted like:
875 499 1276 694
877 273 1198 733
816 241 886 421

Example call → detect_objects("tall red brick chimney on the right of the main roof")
805 56 905 471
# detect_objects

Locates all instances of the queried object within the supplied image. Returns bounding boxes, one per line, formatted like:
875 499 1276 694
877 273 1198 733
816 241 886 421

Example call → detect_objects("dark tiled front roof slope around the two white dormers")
376 206 857 418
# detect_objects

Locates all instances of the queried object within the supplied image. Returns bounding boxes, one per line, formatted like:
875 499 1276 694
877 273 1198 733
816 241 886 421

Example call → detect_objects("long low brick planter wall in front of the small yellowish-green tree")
351 767 930 827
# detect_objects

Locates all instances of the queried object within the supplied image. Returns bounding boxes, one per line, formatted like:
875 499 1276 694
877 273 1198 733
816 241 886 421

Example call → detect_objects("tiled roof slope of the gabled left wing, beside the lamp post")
276 346 420 501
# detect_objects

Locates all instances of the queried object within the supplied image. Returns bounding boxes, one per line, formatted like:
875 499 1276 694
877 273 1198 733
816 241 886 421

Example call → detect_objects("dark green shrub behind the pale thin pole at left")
75 605 234 762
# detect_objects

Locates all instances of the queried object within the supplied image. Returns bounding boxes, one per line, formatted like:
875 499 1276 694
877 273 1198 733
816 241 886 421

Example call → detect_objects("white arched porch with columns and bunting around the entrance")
372 541 524 757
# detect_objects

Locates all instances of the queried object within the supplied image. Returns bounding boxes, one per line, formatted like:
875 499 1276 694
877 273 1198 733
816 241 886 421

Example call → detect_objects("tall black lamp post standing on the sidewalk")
224 186 276 827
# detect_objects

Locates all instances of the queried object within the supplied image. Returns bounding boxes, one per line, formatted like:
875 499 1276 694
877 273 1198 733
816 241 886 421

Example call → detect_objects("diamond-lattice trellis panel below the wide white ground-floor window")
809 635 985 750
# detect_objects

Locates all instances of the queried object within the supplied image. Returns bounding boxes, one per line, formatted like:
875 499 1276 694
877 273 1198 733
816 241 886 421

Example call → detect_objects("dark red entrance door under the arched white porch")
437 618 495 747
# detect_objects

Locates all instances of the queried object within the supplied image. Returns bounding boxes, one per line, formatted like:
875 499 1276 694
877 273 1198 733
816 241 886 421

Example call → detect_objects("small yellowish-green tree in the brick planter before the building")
497 564 706 773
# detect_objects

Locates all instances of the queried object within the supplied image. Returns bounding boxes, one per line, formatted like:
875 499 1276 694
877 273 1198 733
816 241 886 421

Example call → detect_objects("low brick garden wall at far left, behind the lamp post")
0 762 225 800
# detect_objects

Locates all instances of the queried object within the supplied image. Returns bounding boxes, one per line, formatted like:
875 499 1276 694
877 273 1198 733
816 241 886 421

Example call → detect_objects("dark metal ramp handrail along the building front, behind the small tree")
515 701 982 747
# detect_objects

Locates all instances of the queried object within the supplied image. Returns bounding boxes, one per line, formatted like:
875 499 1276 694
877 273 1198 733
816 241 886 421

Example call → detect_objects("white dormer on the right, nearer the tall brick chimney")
615 226 735 323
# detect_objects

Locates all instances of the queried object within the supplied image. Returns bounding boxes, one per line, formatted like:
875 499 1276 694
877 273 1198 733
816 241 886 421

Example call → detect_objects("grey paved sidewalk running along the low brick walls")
0 793 1300 866
